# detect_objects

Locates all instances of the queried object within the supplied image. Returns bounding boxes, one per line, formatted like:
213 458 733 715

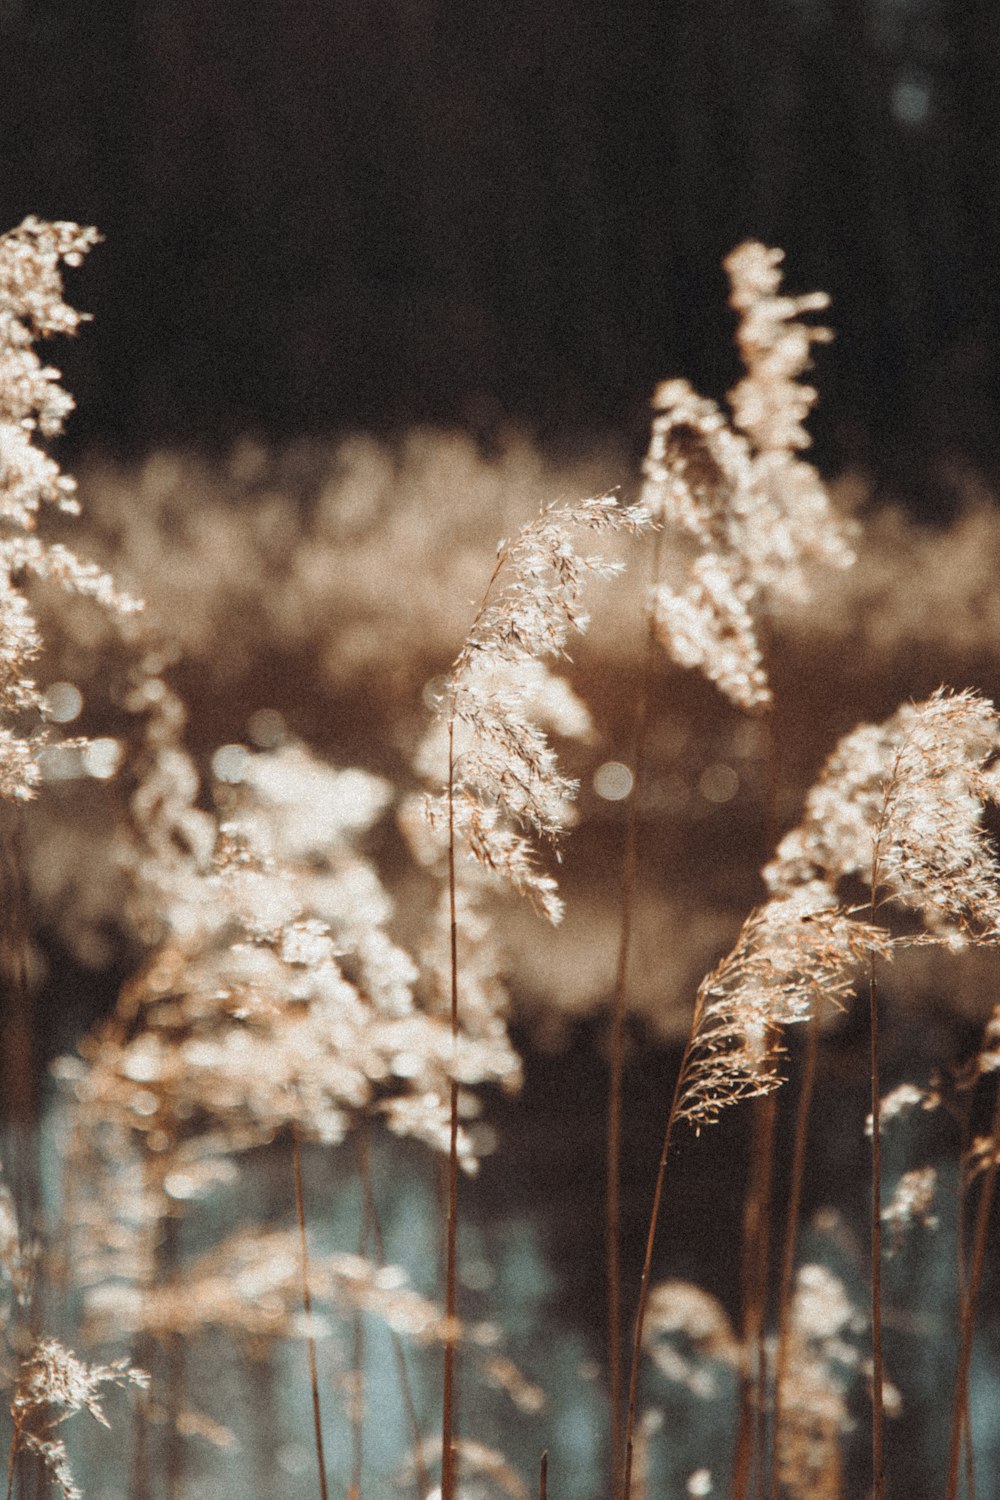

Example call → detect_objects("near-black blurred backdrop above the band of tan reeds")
0 0 1000 513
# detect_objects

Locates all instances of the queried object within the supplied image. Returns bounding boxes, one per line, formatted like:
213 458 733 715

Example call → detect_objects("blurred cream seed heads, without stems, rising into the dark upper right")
643 243 853 710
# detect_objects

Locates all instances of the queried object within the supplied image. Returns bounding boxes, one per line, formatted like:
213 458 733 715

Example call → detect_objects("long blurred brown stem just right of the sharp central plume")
607 528 663 1488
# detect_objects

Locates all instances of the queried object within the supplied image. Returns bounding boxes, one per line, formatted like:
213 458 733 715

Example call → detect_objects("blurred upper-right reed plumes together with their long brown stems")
620 242 853 1488
